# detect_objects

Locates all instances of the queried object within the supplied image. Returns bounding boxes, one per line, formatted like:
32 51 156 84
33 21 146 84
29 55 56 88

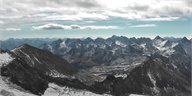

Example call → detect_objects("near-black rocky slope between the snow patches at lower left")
1 59 48 95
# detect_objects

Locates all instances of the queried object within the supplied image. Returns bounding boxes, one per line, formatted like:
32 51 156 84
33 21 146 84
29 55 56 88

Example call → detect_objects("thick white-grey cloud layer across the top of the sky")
0 0 192 21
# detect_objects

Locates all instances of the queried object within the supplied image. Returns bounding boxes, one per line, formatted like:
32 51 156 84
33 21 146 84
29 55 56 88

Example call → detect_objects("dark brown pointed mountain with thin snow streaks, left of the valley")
13 44 76 75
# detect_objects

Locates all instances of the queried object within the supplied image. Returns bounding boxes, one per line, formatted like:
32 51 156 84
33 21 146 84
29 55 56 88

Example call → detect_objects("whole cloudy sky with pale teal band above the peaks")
0 0 192 39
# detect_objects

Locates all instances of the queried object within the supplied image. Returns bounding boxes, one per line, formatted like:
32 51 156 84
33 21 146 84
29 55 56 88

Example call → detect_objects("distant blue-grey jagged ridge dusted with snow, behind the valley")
40 36 190 68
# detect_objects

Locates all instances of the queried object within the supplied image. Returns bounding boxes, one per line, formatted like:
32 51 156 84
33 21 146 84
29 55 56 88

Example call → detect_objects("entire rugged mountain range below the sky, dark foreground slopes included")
0 36 191 96
